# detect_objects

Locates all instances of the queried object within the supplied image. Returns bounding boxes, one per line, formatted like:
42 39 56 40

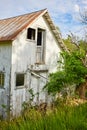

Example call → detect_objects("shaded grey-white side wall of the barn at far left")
0 42 12 117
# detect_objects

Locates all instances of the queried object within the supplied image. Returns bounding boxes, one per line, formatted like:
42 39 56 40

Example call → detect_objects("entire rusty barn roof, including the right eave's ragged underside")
0 9 67 51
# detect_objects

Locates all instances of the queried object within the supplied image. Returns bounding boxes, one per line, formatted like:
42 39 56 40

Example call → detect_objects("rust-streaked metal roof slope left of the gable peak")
0 9 46 41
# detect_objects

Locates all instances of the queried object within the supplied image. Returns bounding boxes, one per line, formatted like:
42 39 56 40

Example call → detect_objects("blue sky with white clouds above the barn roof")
0 0 87 38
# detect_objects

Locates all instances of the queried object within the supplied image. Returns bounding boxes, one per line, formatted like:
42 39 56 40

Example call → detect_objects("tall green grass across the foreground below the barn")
0 104 87 130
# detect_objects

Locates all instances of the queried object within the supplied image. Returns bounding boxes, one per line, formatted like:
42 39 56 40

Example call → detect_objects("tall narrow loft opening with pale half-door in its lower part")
36 28 46 63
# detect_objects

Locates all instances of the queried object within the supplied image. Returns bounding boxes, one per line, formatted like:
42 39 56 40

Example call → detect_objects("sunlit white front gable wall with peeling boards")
11 17 61 115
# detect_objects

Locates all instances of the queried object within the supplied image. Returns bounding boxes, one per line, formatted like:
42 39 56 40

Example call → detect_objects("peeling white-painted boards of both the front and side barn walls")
0 17 61 118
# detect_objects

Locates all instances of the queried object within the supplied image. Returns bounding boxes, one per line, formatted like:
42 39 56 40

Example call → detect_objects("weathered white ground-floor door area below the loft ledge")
30 72 47 105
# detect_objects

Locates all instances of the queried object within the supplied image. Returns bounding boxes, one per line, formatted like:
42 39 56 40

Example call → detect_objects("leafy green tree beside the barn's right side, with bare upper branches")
45 11 87 98
